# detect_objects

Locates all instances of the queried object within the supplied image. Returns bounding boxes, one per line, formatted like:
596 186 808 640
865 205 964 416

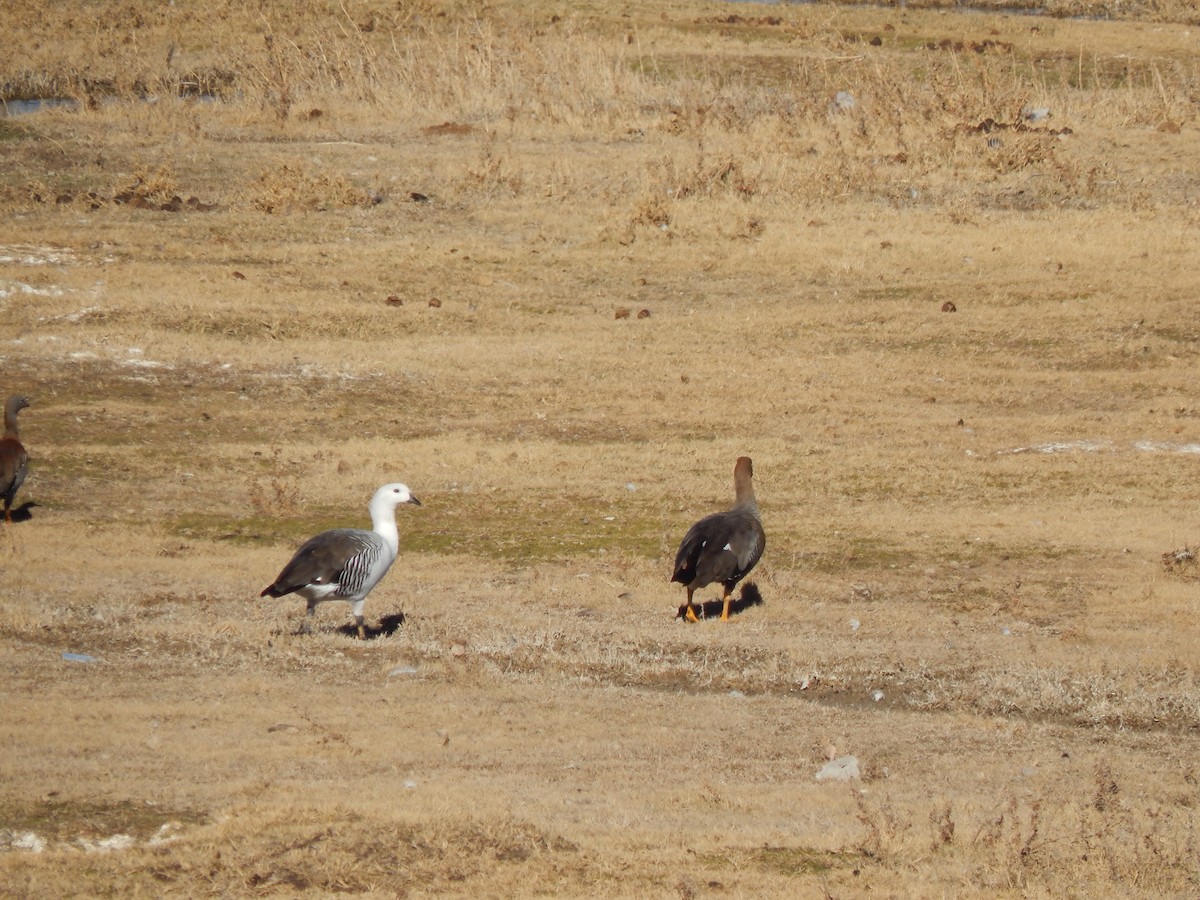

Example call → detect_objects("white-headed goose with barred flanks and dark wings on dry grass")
259 482 421 640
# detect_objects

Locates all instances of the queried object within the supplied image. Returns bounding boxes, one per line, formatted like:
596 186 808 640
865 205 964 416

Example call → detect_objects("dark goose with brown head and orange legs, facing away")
671 456 767 622
